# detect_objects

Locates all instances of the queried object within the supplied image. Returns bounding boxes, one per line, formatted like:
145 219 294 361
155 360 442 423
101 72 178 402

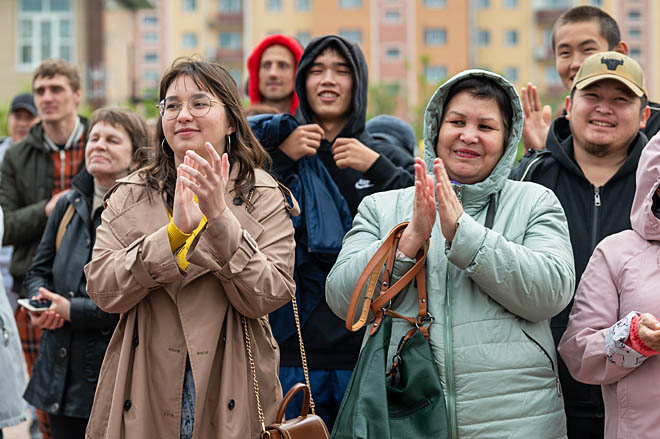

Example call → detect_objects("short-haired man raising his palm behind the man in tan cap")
521 6 660 152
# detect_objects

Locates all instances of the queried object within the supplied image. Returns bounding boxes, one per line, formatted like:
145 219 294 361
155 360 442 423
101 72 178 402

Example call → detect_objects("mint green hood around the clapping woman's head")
424 69 523 205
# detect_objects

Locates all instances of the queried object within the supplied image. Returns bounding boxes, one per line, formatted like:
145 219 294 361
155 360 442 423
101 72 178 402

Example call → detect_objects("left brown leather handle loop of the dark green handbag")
346 222 408 332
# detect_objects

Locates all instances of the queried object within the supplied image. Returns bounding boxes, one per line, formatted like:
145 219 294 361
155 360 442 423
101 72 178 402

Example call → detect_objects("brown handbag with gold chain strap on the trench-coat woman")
241 189 330 439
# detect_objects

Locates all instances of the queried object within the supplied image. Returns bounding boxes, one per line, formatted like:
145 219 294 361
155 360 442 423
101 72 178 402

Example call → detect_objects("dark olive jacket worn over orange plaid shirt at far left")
0 116 88 295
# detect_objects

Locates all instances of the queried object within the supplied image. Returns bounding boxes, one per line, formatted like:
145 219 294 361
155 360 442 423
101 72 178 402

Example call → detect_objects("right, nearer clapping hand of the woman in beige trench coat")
175 142 229 223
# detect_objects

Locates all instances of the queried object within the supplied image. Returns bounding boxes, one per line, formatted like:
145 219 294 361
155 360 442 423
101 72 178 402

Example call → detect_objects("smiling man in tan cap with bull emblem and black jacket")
511 52 650 439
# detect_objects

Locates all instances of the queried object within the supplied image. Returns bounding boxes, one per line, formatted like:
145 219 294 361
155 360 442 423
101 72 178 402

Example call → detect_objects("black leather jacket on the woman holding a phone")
24 169 119 418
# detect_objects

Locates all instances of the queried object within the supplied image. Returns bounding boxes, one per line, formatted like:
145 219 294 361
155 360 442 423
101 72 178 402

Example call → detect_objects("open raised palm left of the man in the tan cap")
521 82 552 153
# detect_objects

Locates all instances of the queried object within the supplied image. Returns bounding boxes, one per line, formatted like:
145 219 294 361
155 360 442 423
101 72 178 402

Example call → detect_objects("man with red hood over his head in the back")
248 34 303 114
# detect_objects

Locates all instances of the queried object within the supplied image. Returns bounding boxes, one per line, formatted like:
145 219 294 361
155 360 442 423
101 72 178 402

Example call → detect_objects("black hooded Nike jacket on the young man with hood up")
270 35 414 369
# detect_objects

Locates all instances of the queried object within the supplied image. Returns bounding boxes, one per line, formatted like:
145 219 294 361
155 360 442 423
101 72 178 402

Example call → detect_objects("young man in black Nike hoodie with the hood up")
270 35 414 429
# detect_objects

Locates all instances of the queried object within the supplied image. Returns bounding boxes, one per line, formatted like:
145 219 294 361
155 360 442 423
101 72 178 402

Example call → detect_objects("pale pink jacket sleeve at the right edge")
559 244 635 384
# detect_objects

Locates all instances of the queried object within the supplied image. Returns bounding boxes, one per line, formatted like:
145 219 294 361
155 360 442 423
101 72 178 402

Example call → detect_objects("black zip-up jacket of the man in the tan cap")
511 117 647 417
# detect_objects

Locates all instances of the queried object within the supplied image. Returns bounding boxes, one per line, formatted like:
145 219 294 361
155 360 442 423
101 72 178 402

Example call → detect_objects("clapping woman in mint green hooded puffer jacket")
326 70 575 439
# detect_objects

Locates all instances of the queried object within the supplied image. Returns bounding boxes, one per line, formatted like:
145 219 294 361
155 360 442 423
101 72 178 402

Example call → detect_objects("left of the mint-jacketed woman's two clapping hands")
399 157 436 258
